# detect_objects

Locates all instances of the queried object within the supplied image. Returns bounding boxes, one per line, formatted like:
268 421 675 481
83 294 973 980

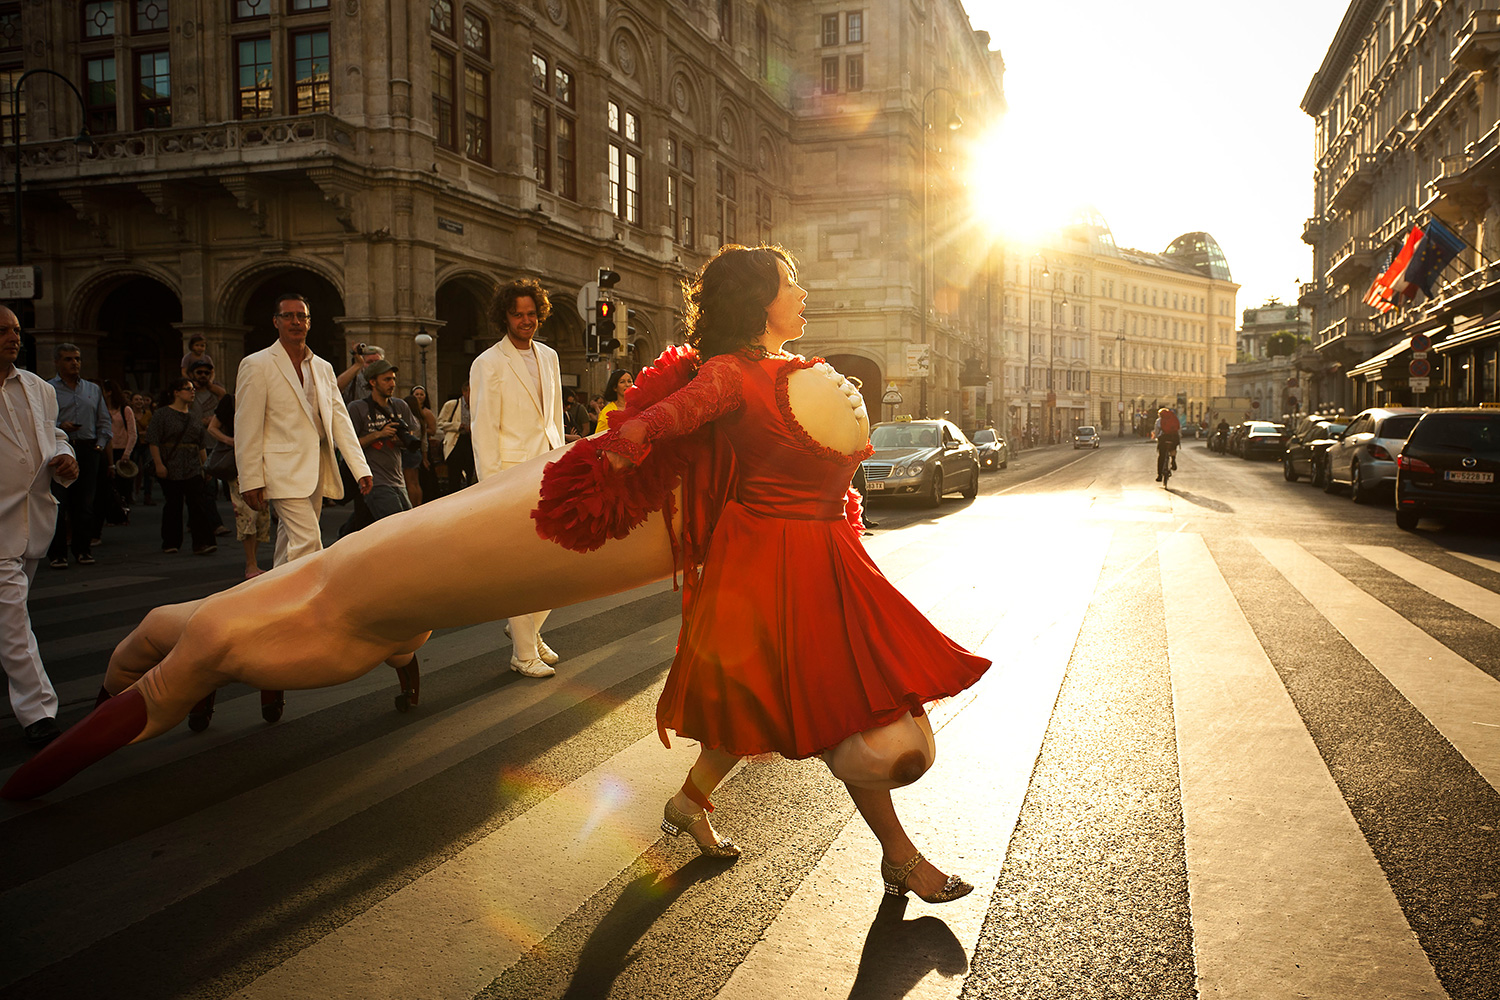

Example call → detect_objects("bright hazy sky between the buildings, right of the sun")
965 0 1349 309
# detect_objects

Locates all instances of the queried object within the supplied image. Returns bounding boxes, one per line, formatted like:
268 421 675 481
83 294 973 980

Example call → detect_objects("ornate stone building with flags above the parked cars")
1301 0 1500 409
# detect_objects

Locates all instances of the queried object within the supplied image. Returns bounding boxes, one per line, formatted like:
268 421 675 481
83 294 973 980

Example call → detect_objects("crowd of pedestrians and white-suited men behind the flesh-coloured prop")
0 280 632 745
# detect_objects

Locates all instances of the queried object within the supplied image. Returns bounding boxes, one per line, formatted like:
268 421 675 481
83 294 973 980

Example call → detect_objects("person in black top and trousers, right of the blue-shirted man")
146 378 218 556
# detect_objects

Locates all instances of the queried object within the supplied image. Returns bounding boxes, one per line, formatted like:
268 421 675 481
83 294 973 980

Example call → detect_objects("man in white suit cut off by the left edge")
0 306 78 747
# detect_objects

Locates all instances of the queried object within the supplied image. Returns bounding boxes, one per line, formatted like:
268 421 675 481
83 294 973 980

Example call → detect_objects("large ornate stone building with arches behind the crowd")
0 0 1004 408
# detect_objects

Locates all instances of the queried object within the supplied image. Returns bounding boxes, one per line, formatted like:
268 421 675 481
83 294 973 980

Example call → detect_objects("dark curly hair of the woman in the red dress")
683 243 797 360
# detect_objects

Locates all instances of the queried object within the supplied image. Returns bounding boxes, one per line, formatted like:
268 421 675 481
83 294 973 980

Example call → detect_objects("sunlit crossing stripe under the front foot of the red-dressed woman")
717 529 1110 1000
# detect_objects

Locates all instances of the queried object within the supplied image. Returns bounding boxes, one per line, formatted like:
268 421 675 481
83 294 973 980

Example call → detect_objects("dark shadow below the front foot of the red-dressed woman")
849 895 969 1000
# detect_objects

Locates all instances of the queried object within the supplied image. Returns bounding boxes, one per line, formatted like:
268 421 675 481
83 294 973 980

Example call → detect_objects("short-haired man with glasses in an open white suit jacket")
234 292 375 721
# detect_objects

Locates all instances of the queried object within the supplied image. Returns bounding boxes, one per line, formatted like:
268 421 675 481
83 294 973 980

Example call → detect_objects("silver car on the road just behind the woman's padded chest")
863 420 980 507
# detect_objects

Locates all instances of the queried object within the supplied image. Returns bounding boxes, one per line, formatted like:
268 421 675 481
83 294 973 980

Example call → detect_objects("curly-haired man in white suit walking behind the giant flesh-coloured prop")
470 279 563 678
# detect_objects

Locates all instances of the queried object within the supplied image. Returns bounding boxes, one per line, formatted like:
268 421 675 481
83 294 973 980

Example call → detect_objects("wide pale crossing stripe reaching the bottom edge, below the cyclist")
1160 534 1446 1000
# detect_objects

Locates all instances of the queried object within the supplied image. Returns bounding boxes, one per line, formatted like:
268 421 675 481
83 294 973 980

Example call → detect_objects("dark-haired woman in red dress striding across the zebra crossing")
567 246 990 903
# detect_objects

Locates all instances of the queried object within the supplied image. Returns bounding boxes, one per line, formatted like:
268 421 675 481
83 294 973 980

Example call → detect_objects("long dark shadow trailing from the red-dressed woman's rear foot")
563 858 726 1000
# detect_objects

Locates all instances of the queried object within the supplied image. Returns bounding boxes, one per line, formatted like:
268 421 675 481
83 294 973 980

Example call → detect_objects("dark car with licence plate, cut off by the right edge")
1397 408 1500 531
